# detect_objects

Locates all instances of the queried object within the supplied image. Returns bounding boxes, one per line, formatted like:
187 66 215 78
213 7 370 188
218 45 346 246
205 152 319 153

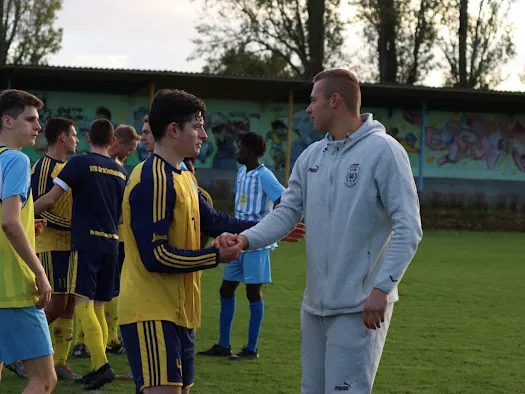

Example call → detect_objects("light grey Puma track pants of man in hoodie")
301 304 394 394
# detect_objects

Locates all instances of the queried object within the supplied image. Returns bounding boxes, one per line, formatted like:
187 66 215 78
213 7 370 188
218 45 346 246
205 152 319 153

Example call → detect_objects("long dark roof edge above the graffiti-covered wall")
0 66 525 114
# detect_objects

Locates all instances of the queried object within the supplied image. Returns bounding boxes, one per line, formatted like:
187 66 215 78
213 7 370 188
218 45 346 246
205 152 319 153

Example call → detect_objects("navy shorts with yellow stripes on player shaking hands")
120 320 195 394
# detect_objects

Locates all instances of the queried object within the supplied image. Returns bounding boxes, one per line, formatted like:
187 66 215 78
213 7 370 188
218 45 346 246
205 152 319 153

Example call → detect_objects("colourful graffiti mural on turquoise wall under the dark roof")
18 91 525 180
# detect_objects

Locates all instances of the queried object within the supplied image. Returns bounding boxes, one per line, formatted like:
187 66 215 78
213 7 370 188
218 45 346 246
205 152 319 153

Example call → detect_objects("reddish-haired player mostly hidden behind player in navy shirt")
104 125 140 354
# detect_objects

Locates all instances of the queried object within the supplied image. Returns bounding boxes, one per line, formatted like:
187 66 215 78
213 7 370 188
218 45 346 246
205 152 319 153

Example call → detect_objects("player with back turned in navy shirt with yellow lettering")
35 119 128 390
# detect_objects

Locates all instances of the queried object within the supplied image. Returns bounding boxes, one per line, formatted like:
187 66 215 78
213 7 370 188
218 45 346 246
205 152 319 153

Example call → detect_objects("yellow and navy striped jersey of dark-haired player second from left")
31 155 73 253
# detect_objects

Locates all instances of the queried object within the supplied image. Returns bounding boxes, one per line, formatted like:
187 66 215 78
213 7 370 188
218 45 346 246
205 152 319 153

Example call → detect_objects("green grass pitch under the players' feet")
0 232 525 394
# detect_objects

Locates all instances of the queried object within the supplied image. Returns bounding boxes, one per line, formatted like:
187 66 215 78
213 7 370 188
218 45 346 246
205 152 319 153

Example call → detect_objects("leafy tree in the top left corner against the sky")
0 0 62 65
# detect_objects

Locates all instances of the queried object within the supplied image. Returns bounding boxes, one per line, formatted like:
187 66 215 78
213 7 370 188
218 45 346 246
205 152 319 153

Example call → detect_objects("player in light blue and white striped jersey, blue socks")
198 132 285 360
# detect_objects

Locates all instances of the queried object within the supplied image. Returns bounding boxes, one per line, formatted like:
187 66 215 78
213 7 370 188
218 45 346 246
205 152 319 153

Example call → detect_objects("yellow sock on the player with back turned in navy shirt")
75 301 108 371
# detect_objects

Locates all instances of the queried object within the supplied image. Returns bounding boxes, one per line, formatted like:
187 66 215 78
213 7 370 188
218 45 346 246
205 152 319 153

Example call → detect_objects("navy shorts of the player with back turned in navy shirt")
69 250 117 302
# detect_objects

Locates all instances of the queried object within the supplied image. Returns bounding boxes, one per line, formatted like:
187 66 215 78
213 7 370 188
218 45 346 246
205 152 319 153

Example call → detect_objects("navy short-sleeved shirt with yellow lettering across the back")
53 153 128 255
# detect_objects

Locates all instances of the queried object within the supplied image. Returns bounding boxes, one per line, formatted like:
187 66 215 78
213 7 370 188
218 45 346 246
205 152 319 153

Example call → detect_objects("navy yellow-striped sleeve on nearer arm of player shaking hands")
129 168 219 274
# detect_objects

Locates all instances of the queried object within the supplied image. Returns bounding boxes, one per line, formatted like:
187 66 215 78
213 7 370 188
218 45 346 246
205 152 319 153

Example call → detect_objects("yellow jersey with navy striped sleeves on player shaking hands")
118 154 255 328
